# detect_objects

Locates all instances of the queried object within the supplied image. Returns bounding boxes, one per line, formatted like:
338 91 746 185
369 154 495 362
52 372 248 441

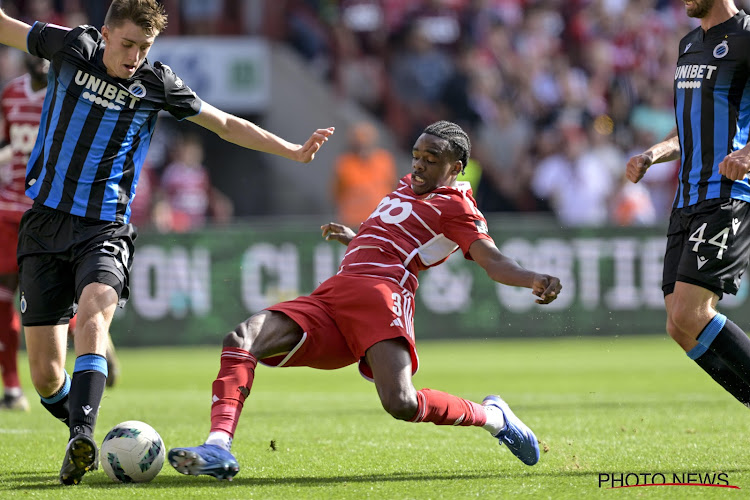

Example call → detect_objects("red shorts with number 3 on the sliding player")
262 275 419 380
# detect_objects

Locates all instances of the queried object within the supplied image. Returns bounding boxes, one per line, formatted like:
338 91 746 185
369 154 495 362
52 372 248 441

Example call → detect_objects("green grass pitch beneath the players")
0 336 750 500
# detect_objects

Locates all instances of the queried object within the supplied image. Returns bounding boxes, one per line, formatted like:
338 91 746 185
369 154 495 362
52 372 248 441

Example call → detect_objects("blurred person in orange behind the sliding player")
333 122 397 228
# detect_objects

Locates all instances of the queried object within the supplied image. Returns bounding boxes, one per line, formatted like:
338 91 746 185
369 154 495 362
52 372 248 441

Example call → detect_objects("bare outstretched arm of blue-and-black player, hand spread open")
188 102 334 163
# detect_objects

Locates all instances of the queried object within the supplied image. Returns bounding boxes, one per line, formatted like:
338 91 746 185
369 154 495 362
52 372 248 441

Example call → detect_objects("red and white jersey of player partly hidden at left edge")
0 74 46 220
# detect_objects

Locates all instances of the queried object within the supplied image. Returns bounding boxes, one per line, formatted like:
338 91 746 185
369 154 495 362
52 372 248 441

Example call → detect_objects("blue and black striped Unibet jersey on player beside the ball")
26 23 201 223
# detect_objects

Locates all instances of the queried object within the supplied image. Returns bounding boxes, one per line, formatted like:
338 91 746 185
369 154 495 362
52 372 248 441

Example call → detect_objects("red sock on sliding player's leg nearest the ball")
211 347 258 437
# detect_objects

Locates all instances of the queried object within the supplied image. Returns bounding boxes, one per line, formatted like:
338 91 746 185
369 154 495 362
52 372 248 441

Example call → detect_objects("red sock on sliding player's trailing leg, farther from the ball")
410 389 487 427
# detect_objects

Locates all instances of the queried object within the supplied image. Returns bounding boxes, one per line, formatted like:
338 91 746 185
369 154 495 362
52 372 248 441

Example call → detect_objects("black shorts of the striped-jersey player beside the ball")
17 204 136 326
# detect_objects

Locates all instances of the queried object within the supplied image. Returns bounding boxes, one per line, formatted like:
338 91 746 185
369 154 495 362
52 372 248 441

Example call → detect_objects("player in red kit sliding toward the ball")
169 121 562 479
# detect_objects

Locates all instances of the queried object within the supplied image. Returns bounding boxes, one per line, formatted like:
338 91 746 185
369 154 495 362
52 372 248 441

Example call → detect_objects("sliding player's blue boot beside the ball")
168 444 240 481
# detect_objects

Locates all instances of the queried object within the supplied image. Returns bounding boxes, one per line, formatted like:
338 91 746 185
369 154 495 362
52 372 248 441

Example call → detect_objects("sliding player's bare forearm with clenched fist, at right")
469 239 562 304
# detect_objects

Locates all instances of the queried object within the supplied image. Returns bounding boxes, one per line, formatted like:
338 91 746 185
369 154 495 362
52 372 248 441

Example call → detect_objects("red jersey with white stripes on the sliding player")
339 174 492 293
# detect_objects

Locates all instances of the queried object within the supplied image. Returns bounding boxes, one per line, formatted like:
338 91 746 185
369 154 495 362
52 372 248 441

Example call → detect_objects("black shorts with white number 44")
662 199 750 298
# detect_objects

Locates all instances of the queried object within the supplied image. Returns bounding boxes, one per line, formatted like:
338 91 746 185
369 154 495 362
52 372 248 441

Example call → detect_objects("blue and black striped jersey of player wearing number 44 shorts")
673 11 750 208
